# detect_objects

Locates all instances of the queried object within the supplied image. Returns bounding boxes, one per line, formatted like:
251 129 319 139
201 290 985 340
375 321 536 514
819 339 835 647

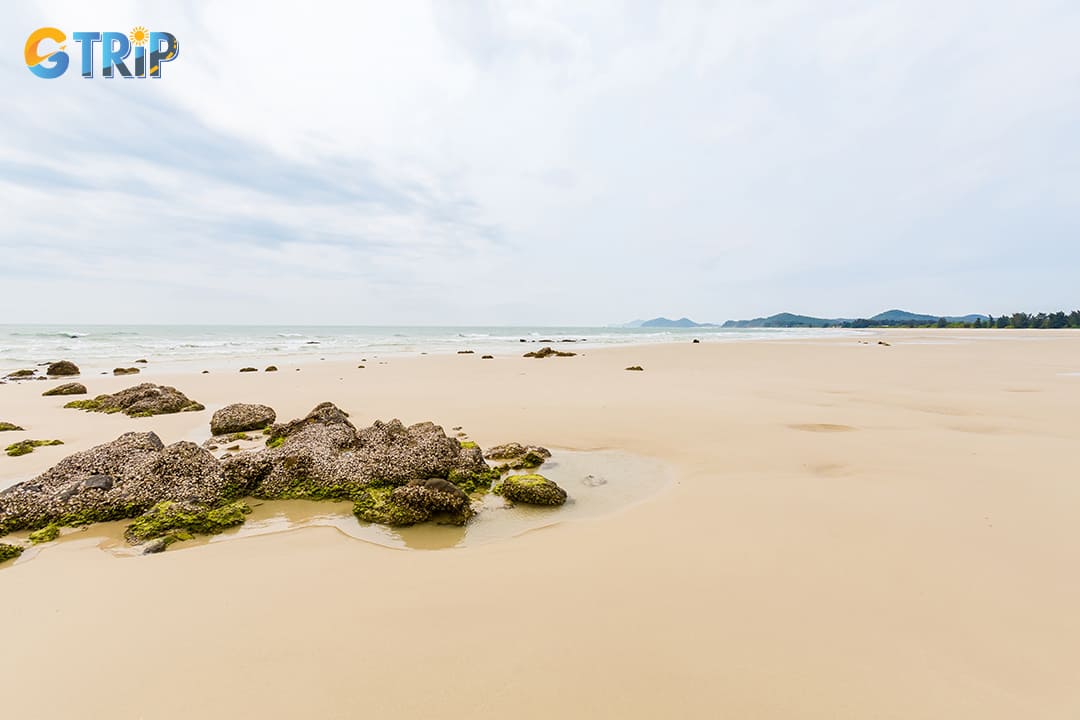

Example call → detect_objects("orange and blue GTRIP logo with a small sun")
25 25 180 80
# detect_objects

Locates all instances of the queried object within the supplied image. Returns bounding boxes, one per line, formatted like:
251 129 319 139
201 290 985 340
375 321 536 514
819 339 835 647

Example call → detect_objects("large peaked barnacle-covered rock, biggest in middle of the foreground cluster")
224 403 489 499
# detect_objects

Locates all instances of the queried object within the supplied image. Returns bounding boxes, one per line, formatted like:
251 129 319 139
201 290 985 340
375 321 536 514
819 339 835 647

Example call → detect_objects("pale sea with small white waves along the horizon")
0 325 853 372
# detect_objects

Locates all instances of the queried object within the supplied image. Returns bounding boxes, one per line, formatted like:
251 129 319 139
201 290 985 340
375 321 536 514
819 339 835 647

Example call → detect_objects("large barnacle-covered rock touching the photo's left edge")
0 433 241 534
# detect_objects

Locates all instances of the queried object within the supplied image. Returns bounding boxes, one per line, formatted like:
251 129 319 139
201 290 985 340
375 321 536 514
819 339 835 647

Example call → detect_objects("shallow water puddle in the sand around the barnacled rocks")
4 450 672 563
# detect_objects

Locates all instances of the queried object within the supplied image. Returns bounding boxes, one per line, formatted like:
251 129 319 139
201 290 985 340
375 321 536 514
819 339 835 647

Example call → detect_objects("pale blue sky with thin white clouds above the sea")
0 0 1080 325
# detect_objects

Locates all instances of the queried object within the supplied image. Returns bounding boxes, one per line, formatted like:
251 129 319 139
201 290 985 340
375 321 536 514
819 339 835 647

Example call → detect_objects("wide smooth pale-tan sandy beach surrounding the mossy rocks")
0 330 1080 720
